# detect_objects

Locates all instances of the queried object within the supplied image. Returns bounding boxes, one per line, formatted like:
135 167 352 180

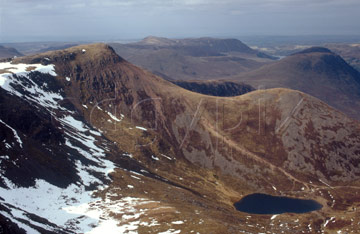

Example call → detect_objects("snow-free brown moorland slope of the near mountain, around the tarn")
1 44 360 233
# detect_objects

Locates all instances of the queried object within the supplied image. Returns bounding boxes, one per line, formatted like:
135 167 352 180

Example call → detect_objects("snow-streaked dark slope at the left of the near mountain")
0 62 159 233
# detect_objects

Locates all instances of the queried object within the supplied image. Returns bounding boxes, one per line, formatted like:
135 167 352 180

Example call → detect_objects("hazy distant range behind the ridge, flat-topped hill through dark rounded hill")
111 37 360 120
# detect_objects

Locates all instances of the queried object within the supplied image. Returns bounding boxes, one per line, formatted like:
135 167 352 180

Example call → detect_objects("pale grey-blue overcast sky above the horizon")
0 0 360 42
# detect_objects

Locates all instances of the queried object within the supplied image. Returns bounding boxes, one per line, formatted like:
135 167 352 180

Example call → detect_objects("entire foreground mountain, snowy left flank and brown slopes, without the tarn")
0 44 360 233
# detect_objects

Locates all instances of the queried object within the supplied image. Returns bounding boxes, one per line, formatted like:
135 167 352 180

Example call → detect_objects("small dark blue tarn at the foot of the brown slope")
234 193 322 214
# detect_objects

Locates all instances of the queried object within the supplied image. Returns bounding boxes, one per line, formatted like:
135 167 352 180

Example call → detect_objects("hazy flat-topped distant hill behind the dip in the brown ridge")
110 37 274 80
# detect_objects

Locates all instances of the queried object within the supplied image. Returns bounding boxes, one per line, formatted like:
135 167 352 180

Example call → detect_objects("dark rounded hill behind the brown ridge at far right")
234 47 360 119
